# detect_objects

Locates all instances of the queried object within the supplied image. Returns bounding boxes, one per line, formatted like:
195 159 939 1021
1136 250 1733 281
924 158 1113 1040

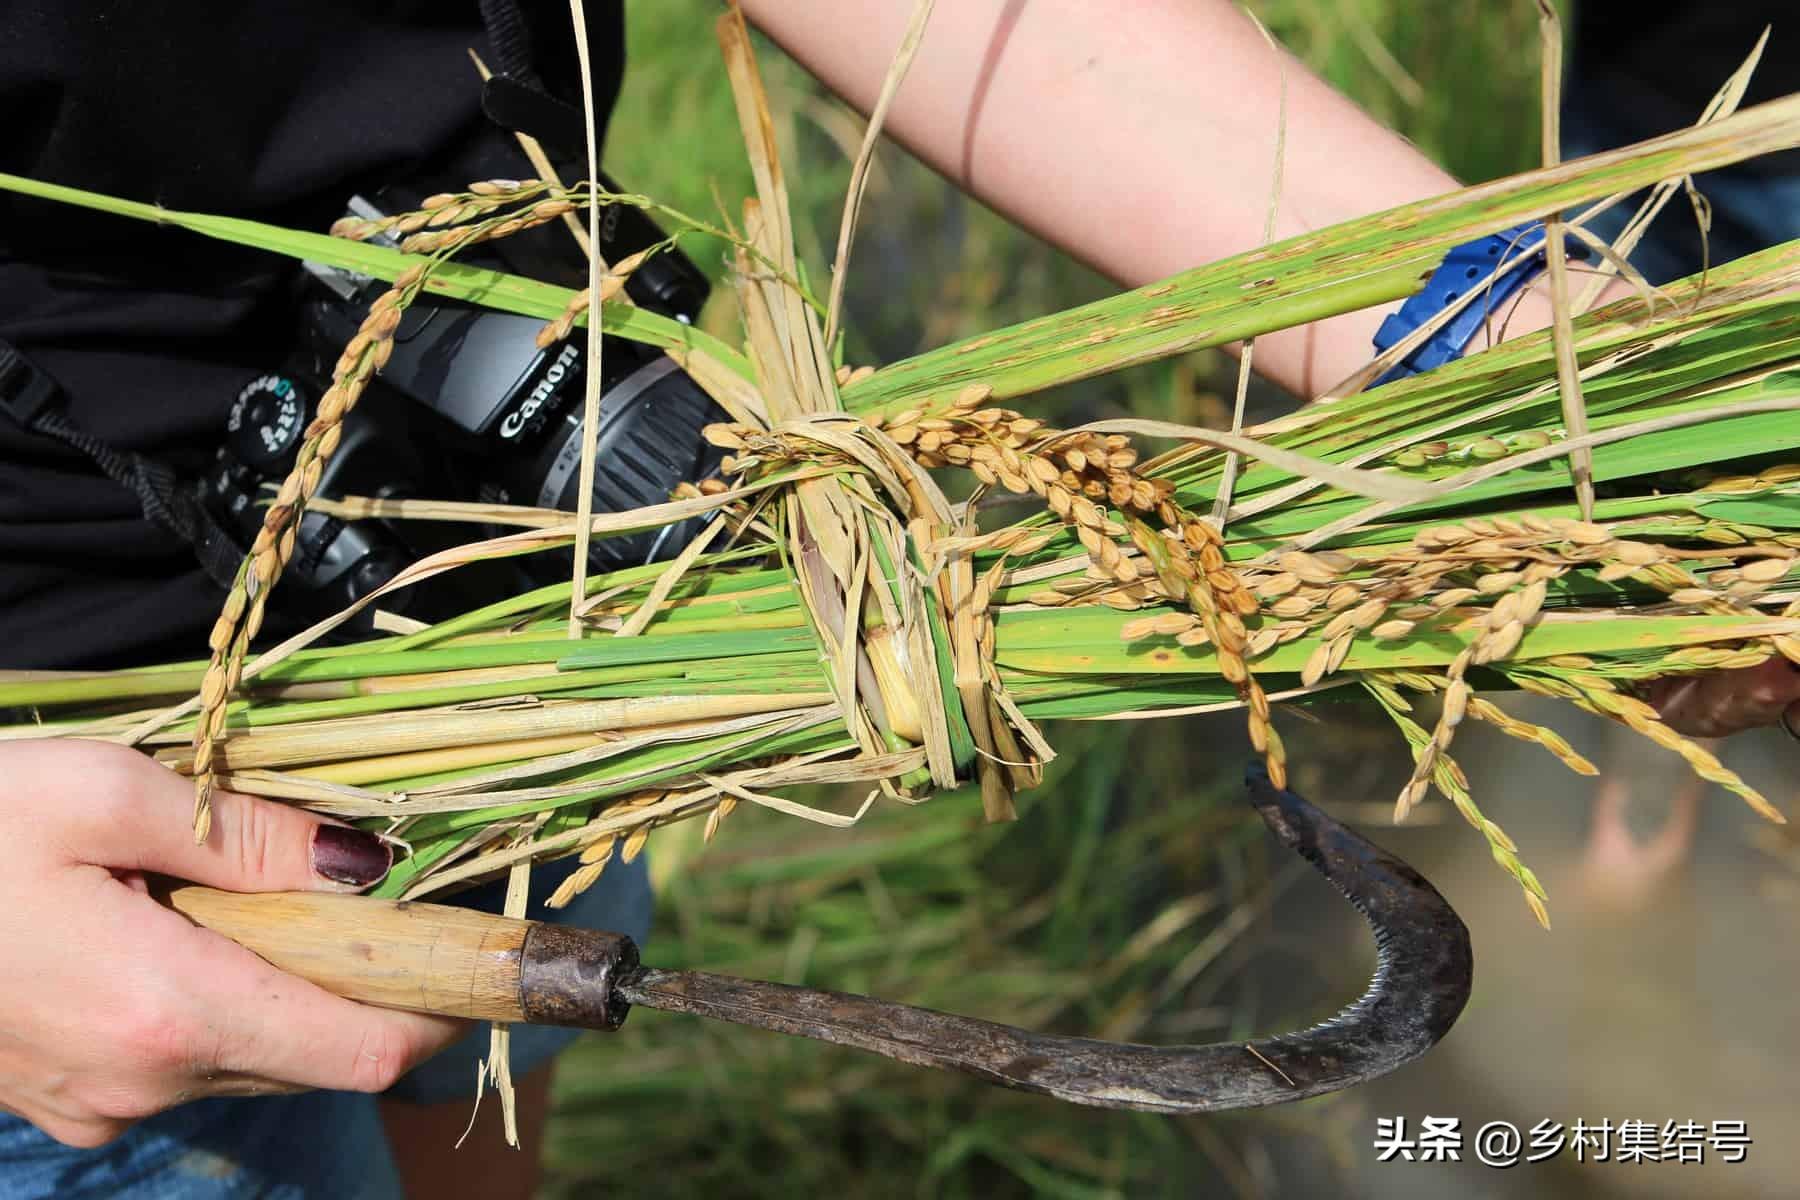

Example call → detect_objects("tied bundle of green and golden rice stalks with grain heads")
0 5 1800 919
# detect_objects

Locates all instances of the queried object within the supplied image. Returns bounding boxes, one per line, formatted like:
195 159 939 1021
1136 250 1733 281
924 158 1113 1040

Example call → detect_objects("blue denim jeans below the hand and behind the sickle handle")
0 858 650 1200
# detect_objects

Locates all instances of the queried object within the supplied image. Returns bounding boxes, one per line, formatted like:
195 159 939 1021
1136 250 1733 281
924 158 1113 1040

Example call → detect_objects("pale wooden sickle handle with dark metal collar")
162 885 637 1029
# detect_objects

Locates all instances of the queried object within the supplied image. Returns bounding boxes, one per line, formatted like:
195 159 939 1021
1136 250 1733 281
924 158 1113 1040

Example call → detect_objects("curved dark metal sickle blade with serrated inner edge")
616 765 1474 1112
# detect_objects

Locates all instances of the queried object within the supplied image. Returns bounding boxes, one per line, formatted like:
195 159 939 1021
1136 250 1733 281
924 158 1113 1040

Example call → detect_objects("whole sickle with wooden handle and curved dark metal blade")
166 766 1474 1112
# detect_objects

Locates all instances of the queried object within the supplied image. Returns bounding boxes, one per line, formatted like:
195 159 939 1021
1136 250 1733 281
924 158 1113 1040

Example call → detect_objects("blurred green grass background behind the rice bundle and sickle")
547 0 1537 1198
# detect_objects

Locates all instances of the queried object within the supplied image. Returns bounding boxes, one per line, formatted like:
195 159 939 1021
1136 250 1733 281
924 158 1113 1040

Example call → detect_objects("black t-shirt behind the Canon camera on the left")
0 0 623 667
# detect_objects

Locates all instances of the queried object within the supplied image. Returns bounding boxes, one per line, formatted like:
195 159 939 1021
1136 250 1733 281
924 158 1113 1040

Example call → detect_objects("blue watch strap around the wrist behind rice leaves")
1375 221 1588 387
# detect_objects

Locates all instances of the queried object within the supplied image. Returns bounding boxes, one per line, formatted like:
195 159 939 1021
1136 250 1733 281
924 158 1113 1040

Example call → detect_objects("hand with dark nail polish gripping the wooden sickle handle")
0 741 466 1146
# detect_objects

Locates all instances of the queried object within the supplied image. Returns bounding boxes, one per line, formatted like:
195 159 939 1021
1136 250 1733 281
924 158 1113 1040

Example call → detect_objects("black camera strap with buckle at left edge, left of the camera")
0 342 243 588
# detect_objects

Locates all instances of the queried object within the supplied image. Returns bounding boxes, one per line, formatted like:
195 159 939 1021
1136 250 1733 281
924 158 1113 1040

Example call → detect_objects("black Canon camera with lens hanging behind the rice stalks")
198 192 725 621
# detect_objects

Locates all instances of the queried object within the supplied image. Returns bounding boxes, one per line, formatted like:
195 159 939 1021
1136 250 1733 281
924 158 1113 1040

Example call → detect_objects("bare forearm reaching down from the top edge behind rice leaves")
745 0 1456 394
